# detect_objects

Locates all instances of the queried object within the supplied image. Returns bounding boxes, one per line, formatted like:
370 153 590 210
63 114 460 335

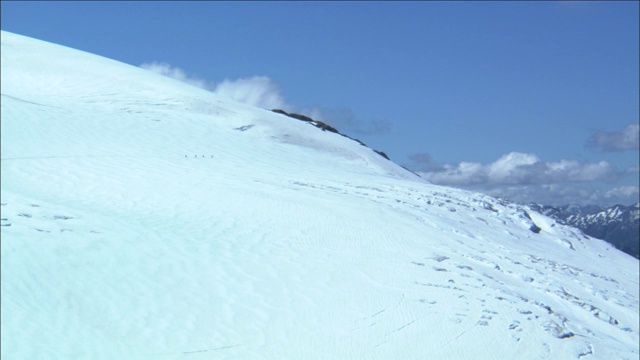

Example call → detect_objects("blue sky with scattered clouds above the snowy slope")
1 1 640 205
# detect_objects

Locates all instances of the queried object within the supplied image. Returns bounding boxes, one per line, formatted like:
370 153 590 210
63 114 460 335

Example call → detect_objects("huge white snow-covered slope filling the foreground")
1 32 639 359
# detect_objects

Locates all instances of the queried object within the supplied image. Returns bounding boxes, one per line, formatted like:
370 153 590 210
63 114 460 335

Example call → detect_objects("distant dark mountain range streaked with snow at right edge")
529 203 640 258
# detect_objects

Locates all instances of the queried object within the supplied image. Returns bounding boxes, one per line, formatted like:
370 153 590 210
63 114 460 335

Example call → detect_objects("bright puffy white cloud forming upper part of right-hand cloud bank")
418 152 618 186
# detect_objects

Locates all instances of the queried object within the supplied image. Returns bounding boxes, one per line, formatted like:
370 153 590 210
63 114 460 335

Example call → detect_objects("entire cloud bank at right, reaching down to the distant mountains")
408 152 638 205
